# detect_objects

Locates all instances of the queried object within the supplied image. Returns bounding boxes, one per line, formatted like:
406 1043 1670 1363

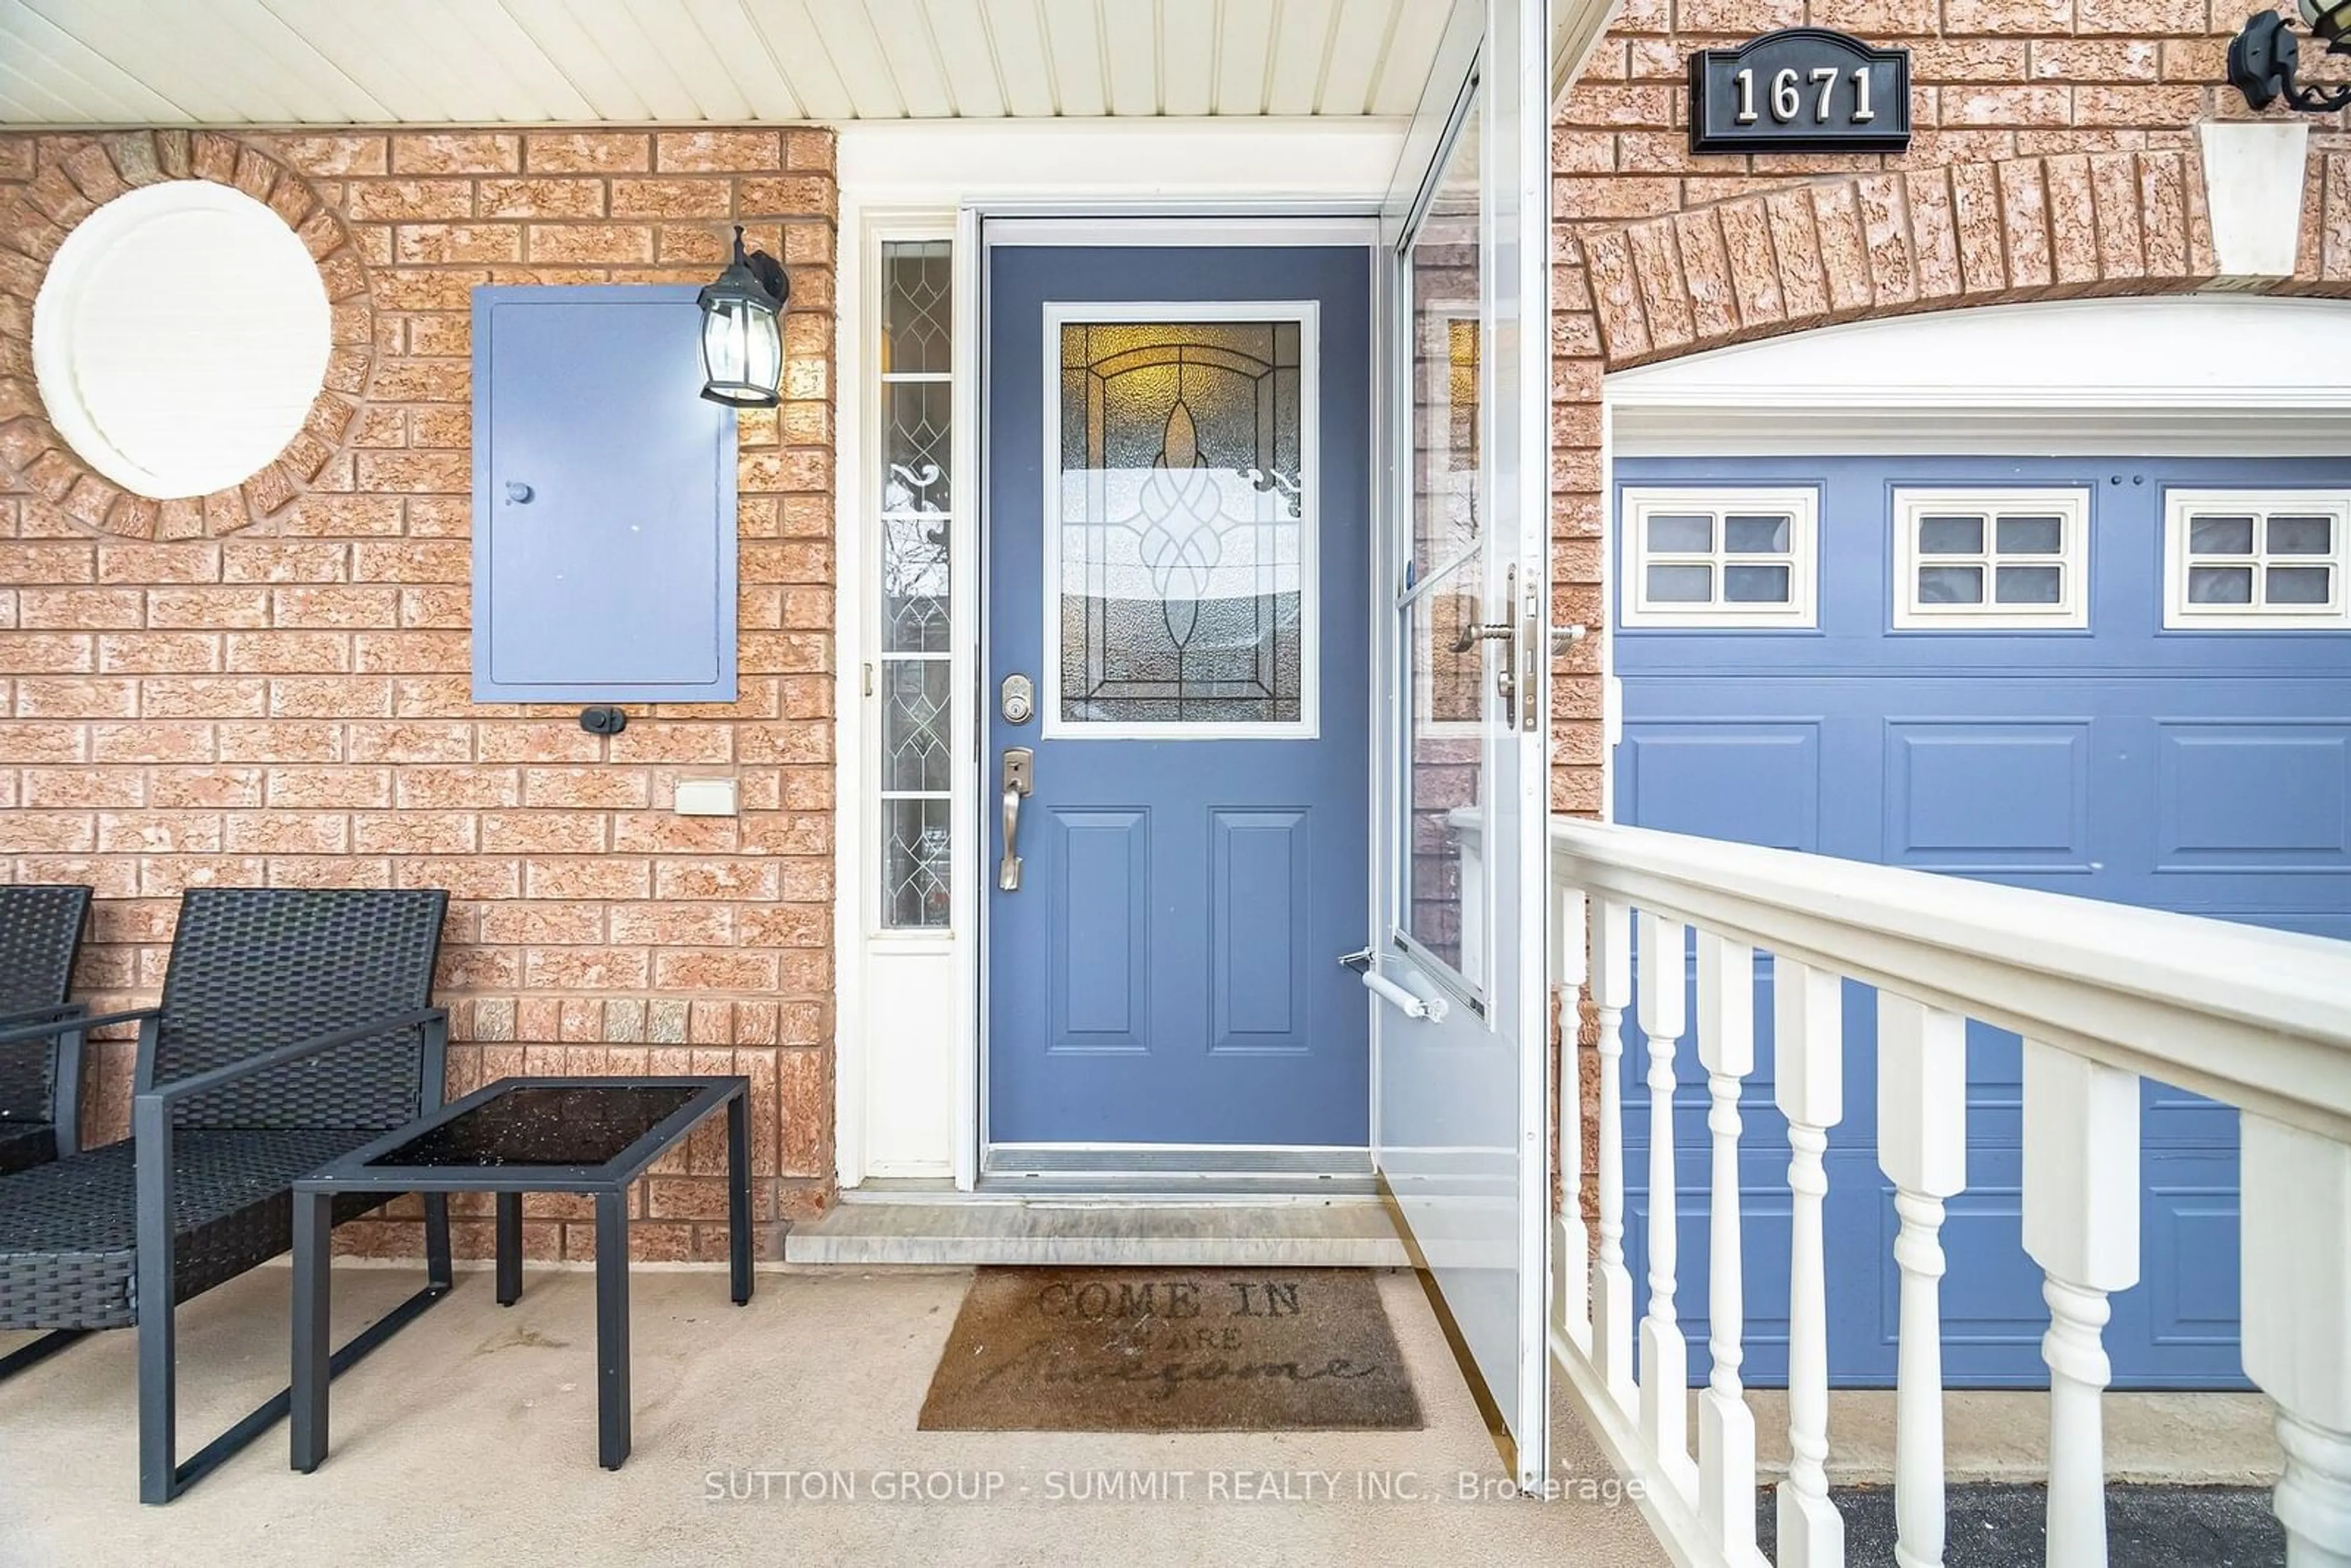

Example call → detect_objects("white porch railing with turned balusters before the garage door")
1551 820 2351 1568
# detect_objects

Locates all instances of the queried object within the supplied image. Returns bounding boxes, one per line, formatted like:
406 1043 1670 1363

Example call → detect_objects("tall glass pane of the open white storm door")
1399 86 1476 989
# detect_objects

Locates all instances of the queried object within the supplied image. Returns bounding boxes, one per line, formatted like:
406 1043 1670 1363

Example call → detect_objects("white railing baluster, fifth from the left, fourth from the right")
1772 959 1845 1568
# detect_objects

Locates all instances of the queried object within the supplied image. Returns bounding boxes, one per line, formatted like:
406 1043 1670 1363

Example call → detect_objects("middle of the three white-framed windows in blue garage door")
1892 489 2090 632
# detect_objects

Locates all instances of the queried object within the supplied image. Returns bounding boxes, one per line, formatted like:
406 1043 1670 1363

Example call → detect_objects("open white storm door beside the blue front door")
1373 0 1550 1486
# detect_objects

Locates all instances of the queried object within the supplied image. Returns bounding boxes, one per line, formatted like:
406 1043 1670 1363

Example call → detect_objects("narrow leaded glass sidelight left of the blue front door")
874 240 954 929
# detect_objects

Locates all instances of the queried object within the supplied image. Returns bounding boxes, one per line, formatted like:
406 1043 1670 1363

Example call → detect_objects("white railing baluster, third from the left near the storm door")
1638 910 1697 1502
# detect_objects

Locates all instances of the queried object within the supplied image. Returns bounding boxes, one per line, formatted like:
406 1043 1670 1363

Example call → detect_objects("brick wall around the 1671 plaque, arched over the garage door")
1551 0 2351 1213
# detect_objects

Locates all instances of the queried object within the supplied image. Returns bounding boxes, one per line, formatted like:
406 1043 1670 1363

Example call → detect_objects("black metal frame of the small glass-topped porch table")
291 1077 752 1474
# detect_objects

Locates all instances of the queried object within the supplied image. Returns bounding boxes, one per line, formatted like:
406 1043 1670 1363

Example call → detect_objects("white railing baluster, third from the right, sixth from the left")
1878 992 1968 1568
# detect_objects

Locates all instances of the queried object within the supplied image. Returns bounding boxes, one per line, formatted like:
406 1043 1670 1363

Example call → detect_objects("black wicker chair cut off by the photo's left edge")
0 884 89 1176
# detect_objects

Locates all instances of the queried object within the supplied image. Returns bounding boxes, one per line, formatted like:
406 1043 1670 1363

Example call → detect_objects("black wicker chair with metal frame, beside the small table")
0 888 451 1502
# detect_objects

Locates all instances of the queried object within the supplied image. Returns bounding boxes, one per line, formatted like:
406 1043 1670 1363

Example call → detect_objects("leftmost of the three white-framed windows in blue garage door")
1622 489 1820 628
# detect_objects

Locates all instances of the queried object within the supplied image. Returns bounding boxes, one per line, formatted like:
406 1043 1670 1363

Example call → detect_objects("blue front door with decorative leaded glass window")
983 244 1373 1147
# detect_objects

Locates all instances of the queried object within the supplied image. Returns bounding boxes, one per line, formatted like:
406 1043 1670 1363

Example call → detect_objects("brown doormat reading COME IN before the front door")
919 1269 1420 1431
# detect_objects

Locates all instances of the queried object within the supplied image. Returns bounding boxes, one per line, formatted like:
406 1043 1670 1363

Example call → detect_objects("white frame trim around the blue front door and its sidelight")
832 120 1406 1190
